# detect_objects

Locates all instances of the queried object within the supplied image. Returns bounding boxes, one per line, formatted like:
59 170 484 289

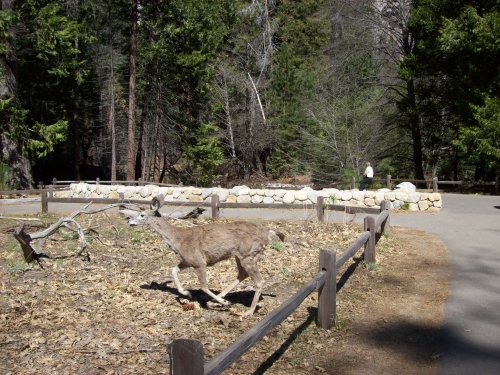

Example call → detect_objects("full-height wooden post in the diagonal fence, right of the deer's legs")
316 249 337 329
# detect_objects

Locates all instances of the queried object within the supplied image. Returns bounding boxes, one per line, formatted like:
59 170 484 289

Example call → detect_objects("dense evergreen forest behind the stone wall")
0 0 500 189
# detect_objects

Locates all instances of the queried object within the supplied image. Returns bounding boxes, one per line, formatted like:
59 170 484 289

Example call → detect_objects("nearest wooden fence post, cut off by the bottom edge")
168 339 203 375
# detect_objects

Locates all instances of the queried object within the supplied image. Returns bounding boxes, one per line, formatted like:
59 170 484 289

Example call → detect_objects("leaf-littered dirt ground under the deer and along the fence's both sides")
0 210 449 374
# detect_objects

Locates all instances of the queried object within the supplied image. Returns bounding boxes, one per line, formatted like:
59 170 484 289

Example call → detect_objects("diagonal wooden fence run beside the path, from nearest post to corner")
169 202 389 375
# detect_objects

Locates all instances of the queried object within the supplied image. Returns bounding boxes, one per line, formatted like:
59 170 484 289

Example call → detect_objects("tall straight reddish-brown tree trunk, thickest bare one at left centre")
127 0 139 180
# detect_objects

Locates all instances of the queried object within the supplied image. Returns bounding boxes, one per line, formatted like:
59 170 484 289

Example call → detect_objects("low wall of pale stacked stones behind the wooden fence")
54 183 442 211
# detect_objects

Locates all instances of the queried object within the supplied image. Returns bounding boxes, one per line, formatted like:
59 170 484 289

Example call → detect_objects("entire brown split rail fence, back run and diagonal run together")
0 184 390 375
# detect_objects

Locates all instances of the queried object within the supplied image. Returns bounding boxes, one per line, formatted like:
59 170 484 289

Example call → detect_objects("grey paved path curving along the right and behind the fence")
0 194 500 375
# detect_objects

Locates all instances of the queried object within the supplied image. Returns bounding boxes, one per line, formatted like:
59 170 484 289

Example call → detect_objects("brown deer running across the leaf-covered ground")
120 199 285 316
